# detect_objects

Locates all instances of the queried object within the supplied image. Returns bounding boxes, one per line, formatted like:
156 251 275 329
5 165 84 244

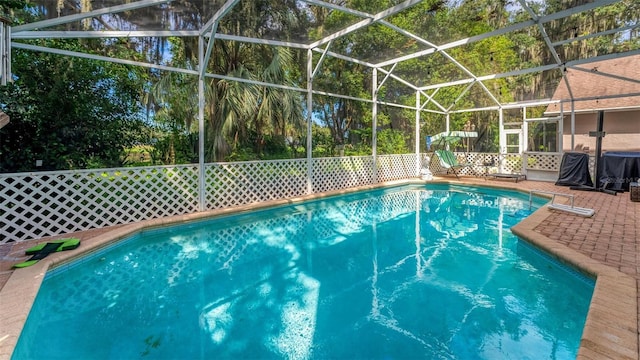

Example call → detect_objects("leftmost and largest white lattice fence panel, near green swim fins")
0 166 198 243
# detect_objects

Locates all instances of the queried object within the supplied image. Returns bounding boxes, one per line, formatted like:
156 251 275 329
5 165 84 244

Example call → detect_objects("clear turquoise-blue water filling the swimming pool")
13 185 594 359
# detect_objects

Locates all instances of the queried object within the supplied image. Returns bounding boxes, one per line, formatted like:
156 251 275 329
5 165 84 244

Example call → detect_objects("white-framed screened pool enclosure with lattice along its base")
0 0 640 243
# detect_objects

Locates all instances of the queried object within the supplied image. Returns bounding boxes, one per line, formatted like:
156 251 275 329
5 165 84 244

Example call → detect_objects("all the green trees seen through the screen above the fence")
0 0 640 171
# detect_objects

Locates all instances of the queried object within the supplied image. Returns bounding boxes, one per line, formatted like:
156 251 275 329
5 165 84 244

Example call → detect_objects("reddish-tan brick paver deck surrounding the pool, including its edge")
0 177 640 359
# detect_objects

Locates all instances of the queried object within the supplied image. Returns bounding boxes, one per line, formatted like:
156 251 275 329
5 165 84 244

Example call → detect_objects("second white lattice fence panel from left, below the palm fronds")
205 159 307 209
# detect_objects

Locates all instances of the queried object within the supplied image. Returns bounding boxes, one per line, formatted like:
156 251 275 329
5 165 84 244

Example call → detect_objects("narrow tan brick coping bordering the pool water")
0 179 638 359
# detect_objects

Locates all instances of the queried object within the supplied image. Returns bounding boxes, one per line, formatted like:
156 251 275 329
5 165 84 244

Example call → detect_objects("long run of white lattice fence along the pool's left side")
5 154 478 243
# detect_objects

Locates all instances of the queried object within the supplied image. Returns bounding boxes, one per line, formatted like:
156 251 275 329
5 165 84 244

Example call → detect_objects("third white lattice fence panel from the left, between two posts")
312 156 373 193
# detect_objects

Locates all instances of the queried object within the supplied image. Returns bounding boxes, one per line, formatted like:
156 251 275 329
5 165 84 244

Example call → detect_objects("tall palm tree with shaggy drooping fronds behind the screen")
154 0 304 161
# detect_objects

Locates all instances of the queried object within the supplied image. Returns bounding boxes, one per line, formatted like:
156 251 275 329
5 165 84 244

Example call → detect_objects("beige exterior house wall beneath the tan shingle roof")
562 110 640 154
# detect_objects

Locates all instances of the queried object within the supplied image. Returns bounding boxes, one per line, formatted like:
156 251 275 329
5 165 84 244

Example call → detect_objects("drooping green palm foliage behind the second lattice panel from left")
154 35 304 161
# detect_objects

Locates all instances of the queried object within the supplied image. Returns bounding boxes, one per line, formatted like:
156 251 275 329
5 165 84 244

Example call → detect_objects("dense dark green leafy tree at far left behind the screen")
0 40 145 172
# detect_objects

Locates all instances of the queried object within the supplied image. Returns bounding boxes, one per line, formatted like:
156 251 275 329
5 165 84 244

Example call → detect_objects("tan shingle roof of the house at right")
546 55 640 114
